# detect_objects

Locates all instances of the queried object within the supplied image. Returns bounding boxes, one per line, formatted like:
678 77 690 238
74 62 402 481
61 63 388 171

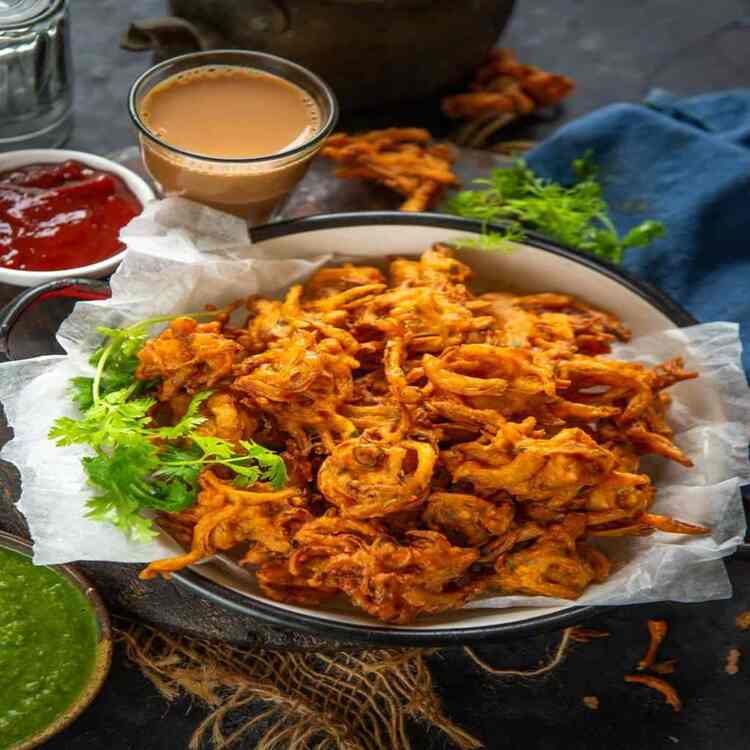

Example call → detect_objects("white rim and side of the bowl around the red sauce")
0 148 155 286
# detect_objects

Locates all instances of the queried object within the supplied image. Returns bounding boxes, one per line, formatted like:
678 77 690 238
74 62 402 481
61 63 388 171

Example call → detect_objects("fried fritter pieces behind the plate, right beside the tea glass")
321 128 458 211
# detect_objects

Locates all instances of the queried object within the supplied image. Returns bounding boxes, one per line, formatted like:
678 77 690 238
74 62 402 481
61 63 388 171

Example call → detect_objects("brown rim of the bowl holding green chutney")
0 530 112 750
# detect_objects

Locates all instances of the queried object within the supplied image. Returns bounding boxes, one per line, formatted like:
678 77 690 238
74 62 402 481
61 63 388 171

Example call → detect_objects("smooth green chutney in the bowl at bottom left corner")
0 547 99 750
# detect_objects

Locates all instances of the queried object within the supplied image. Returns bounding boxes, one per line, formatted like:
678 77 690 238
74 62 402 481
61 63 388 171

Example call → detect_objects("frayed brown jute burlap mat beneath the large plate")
117 622 572 750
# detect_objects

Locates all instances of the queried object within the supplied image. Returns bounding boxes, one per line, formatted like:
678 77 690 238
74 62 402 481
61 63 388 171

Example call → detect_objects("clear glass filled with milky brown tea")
128 50 338 225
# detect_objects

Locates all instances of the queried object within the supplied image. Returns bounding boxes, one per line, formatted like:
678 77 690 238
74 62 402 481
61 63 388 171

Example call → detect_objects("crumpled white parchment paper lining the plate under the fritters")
0 198 750 608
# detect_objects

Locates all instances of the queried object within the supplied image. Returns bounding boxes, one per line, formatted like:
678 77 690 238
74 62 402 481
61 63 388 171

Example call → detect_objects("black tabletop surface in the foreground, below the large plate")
29 561 750 750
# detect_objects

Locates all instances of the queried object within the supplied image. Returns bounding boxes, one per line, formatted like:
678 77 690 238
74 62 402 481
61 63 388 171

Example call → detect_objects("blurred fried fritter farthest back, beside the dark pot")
442 49 575 148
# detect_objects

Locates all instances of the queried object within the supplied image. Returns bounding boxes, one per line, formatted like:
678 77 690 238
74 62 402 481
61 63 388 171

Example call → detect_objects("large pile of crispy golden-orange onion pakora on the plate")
136 245 707 623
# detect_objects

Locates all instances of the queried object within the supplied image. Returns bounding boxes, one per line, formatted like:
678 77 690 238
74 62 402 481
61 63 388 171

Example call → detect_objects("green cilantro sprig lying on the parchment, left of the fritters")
49 313 287 542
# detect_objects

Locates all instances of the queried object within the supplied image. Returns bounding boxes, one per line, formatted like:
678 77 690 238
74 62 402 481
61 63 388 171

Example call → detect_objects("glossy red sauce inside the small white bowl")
0 161 143 271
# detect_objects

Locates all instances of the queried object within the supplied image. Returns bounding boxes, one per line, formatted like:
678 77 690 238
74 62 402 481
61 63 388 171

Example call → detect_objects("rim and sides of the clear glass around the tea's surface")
128 50 338 226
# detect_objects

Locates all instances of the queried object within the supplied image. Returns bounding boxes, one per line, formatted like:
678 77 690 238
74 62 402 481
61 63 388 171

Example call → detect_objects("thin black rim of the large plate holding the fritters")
160 211 698 646
